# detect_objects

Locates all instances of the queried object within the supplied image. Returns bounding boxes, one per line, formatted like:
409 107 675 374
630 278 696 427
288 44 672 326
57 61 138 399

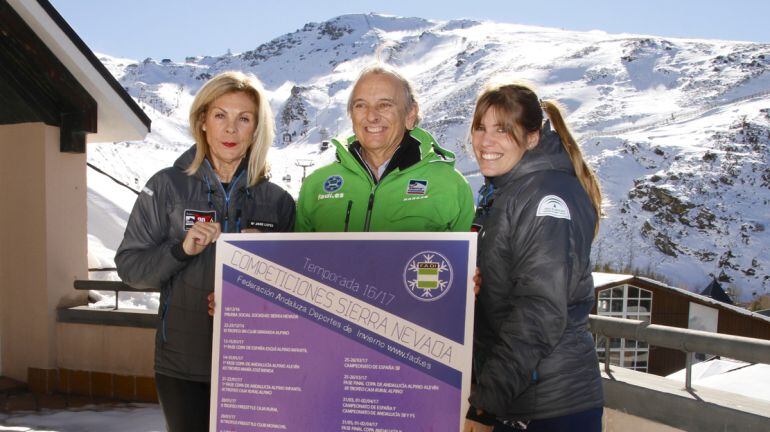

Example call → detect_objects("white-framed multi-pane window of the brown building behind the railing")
596 284 652 372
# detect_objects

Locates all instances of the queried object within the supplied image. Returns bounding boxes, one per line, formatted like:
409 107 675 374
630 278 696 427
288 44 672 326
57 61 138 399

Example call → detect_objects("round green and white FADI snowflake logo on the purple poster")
404 251 453 301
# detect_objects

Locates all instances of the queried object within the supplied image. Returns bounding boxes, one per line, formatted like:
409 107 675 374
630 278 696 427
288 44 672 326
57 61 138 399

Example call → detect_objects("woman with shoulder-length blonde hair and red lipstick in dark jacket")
115 72 295 432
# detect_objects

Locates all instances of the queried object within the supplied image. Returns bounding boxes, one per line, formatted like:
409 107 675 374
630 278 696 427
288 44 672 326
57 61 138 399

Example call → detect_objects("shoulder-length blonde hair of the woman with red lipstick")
185 71 275 186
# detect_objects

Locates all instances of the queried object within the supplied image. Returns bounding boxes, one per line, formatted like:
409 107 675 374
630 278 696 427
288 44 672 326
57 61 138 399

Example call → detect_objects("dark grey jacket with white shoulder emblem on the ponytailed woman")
470 123 603 420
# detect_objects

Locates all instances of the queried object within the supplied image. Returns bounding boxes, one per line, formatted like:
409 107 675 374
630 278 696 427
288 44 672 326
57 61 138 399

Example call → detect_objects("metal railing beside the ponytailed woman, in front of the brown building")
588 315 770 390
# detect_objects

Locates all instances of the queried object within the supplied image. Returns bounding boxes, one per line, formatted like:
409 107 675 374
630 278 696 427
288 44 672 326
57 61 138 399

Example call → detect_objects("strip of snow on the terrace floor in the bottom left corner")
0 404 166 432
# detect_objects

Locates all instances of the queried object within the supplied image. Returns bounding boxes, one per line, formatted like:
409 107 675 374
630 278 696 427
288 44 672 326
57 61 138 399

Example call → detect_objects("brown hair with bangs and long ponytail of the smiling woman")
471 83 602 237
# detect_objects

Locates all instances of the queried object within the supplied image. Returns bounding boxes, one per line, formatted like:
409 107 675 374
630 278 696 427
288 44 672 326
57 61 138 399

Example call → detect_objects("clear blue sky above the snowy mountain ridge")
49 0 770 60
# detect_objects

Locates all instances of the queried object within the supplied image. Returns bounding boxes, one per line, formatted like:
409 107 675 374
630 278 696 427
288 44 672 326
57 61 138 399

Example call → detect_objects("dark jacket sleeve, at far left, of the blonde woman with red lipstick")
115 173 187 289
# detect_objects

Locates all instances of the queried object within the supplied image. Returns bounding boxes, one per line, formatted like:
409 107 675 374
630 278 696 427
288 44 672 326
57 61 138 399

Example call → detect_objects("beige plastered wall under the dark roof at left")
0 123 88 381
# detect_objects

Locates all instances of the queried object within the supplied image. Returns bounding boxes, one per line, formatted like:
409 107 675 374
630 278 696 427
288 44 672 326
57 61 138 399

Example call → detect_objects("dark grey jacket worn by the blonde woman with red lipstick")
115 146 295 382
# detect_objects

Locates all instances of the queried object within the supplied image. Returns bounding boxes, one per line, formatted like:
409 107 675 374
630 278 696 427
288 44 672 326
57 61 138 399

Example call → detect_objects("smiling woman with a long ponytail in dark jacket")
464 84 604 432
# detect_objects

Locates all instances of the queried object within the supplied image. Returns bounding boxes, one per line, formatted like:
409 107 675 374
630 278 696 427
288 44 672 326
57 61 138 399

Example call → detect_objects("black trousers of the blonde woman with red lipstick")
155 373 211 432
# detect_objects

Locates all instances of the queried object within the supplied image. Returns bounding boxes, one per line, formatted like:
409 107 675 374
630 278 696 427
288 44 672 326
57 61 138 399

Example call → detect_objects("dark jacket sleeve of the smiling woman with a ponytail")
470 197 574 414
